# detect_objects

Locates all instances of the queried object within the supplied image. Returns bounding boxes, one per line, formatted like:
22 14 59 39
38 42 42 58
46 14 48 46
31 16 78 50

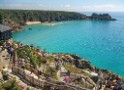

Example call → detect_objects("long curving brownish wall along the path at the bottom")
12 67 88 90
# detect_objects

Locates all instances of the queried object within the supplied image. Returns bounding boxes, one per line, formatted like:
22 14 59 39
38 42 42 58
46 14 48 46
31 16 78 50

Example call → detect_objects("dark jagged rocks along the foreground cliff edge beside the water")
65 54 122 76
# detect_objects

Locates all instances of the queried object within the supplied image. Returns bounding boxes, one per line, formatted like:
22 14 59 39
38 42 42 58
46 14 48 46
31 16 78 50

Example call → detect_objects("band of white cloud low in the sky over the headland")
0 3 124 12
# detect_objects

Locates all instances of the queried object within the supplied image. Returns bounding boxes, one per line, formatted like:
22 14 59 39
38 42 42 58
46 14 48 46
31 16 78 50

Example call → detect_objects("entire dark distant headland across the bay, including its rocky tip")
0 10 116 31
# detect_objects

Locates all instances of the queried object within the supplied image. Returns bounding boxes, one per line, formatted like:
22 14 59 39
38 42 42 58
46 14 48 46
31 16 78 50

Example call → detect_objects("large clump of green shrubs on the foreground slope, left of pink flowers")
17 46 46 68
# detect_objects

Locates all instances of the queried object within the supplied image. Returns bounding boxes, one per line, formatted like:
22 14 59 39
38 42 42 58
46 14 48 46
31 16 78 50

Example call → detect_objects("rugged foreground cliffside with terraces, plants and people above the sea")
0 41 124 90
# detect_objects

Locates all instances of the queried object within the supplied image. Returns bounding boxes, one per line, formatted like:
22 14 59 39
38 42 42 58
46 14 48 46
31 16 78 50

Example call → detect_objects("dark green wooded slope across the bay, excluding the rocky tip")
0 10 87 29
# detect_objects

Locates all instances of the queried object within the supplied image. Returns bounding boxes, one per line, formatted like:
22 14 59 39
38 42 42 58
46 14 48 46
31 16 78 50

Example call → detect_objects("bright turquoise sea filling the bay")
13 13 124 76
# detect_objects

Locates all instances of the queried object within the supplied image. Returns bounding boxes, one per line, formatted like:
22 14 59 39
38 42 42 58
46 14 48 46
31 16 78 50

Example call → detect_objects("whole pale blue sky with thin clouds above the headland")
0 0 124 12
